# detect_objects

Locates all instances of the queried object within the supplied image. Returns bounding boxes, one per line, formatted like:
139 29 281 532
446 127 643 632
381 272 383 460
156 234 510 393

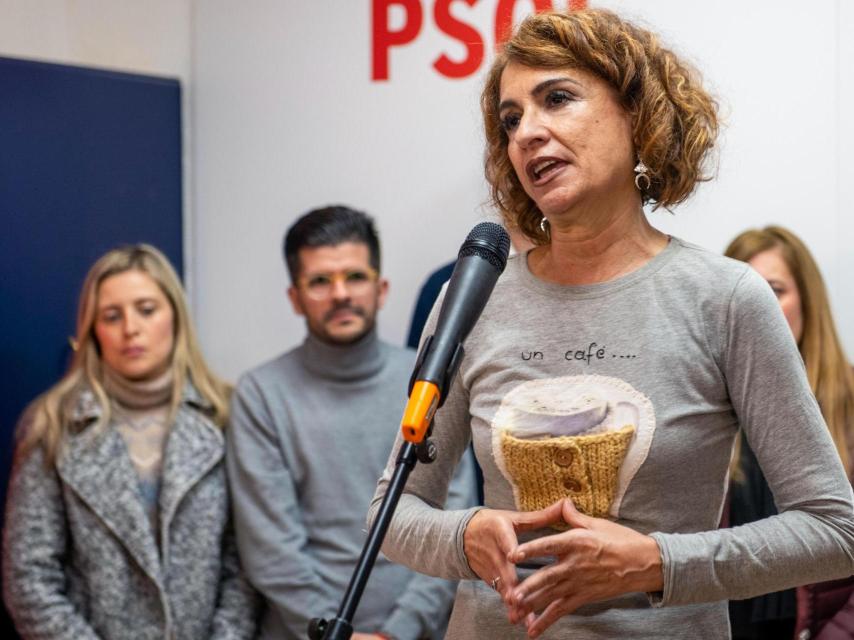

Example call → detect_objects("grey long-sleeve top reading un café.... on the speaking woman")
372 238 854 640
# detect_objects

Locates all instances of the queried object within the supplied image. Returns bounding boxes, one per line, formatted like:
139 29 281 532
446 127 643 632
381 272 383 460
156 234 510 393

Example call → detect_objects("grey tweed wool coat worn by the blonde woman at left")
3 385 257 640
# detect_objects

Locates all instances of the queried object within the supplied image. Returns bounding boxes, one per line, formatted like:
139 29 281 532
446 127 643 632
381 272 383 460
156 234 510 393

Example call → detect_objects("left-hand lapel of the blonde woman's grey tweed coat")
57 392 162 587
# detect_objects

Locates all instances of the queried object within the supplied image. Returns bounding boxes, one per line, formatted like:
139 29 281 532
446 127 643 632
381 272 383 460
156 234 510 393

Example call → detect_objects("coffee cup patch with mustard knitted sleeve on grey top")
492 375 655 529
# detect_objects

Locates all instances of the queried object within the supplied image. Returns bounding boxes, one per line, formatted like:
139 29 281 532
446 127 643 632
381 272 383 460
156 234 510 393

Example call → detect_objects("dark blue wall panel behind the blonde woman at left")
0 58 183 638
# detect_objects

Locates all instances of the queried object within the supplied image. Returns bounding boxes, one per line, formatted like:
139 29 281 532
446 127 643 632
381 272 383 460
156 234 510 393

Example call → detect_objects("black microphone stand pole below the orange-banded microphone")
308 438 436 640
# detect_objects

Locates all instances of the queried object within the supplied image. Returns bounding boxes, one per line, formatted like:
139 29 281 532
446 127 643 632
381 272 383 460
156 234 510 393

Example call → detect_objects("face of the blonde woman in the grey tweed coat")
95 269 175 380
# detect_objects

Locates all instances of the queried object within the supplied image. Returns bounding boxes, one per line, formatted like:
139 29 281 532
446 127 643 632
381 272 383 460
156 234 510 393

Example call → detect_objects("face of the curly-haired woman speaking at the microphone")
499 63 638 220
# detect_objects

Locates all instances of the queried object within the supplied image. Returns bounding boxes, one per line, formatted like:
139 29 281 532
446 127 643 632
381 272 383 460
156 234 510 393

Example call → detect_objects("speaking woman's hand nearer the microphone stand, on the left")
463 509 560 597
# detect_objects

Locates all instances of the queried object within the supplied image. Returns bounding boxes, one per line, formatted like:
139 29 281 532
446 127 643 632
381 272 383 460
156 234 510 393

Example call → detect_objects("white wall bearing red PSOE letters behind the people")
193 0 854 377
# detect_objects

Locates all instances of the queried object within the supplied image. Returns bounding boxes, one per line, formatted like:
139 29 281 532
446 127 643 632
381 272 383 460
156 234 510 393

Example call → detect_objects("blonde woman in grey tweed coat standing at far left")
3 244 255 640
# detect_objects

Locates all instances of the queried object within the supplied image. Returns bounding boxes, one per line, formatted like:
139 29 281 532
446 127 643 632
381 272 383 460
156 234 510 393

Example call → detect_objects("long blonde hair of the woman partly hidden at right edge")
724 226 854 477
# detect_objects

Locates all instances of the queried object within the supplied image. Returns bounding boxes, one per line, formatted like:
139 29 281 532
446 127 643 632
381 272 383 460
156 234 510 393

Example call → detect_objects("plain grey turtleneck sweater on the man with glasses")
226 332 474 640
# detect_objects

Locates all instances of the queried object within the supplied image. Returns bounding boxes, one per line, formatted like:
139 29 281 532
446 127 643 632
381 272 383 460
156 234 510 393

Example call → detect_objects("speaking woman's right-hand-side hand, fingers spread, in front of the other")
502 499 664 638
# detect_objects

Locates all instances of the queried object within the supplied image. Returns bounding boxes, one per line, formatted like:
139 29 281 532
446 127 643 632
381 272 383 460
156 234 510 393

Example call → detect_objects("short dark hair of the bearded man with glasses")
284 204 380 283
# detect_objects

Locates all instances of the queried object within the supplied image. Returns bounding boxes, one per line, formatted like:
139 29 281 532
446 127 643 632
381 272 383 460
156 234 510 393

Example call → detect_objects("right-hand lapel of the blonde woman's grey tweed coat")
160 398 225 545
